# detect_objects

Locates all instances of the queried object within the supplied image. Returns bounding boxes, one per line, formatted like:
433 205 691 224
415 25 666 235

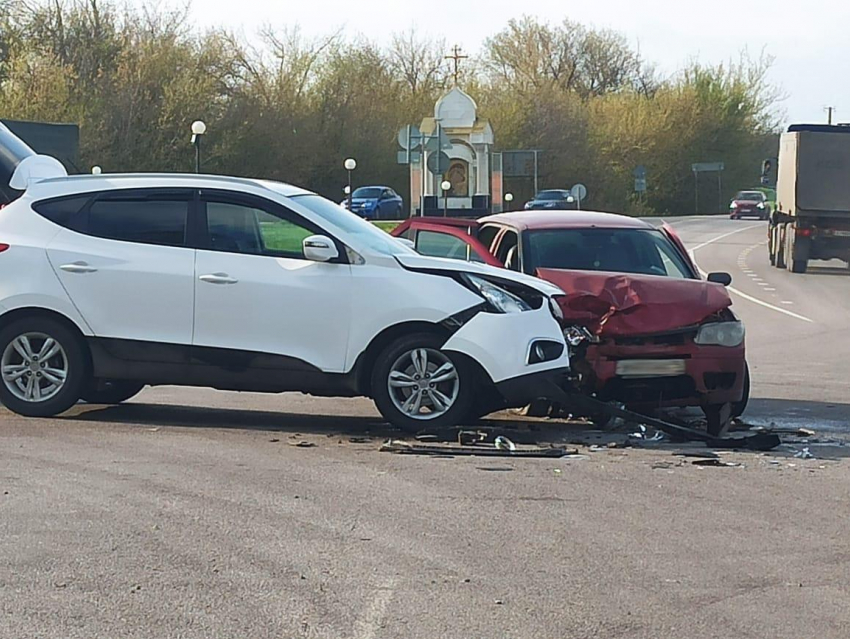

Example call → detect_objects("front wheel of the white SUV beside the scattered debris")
371 333 476 432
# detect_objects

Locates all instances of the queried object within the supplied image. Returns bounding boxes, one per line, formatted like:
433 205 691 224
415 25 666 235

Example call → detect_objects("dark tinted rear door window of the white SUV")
86 195 189 246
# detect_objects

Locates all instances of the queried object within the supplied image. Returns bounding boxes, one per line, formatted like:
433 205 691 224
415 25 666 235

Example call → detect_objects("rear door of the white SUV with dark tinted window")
44 189 195 345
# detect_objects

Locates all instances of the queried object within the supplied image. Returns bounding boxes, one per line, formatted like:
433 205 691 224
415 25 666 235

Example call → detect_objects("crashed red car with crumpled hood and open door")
392 211 749 434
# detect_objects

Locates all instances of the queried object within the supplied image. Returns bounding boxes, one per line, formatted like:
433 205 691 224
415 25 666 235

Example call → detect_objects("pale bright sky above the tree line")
176 0 850 123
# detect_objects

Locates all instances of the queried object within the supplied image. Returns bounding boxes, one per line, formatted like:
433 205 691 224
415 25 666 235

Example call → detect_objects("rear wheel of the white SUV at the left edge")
0 317 89 417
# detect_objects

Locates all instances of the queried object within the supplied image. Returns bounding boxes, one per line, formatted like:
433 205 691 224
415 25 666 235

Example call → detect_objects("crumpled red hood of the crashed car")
537 269 732 336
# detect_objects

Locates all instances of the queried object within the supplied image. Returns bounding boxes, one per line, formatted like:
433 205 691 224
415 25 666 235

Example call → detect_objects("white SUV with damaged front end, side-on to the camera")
0 151 568 429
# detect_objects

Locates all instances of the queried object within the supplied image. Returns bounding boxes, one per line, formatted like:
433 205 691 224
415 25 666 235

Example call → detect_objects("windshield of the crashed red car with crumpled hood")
527 229 694 279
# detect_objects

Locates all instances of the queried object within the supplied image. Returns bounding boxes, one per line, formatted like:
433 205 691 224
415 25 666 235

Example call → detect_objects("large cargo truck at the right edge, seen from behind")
768 124 850 273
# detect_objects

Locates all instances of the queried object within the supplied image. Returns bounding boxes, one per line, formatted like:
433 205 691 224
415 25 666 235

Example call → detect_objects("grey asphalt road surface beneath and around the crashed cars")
0 219 850 639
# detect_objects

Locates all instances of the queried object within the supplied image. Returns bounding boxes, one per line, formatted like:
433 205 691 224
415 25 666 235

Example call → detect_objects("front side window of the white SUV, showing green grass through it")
207 201 315 258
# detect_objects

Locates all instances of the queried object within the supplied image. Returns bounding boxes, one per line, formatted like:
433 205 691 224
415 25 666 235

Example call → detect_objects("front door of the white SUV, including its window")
193 191 357 372
